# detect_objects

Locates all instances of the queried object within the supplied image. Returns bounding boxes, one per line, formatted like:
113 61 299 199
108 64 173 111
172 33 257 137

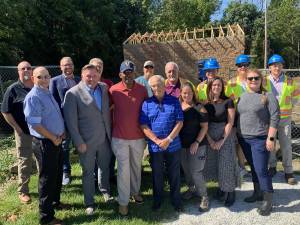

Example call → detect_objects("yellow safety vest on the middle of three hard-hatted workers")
225 76 248 104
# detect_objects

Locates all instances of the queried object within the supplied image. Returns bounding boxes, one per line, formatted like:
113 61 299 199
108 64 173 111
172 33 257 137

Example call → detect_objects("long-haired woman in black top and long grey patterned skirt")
205 77 239 207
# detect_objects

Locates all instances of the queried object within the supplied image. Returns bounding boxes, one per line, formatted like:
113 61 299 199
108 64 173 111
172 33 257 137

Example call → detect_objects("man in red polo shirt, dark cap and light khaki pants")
109 60 148 216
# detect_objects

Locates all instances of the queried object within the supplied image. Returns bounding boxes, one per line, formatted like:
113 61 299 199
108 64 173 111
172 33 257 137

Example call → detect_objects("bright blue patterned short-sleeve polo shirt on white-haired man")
140 94 183 152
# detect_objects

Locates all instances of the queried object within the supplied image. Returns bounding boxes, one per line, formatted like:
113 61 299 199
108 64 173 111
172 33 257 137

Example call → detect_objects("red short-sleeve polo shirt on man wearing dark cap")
109 81 148 140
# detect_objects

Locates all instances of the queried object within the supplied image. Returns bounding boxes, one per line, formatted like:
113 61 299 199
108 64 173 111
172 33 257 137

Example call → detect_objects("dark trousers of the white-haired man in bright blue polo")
150 151 181 207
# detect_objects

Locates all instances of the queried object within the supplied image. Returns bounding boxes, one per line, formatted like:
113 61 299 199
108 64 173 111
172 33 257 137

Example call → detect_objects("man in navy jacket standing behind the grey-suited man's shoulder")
49 57 80 185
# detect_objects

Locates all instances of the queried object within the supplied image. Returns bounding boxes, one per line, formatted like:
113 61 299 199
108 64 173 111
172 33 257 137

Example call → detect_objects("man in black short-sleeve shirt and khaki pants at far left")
1 61 33 204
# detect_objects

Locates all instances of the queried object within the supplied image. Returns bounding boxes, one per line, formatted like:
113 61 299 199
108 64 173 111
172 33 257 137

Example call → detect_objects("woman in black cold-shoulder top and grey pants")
179 82 209 211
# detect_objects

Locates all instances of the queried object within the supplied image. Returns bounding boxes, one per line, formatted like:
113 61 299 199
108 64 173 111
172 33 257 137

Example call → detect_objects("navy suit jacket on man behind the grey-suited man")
49 74 80 108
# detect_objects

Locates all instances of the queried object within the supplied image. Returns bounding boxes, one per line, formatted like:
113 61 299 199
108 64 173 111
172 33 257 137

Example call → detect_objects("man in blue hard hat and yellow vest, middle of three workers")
225 54 250 177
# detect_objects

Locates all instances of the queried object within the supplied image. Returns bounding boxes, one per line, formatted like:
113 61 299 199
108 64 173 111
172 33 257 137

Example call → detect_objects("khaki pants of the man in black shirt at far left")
15 132 33 194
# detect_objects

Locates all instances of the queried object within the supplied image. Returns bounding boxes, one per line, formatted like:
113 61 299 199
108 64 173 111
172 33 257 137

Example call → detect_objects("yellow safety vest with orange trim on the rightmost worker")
264 75 300 119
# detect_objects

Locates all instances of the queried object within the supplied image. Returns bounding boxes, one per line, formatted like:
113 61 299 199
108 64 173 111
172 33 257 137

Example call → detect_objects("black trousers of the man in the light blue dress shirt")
34 138 63 224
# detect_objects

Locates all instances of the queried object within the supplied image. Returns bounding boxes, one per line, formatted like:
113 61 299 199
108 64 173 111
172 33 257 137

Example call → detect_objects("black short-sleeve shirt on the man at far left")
1 80 30 134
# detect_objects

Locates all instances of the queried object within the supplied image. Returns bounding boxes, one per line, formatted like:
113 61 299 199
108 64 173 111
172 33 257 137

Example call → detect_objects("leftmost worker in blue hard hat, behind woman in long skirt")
197 58 220 101
